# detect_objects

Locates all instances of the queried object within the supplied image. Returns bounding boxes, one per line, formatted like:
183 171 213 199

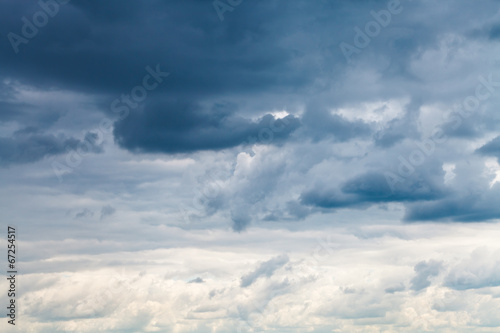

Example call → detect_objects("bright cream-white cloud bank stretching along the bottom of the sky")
5 225 500 332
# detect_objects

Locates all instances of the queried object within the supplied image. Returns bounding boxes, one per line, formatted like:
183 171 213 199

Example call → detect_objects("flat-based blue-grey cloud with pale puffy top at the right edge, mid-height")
299 143 500 223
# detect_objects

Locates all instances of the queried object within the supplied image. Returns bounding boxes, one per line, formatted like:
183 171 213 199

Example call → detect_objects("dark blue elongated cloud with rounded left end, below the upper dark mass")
114 101 299 153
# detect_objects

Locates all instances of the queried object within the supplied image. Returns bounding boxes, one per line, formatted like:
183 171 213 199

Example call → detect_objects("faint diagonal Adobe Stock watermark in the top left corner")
7 0 70 54
